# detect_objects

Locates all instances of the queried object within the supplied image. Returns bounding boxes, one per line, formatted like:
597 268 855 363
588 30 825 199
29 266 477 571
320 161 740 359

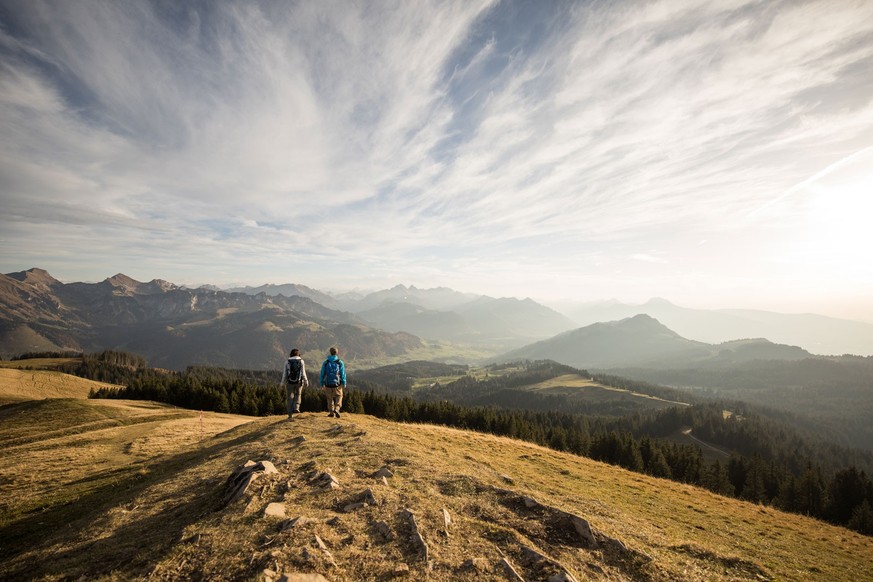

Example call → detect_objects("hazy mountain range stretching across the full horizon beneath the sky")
0 268 873 369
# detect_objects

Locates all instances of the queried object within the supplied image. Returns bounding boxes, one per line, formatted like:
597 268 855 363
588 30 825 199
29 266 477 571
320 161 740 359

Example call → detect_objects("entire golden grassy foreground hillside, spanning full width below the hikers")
0 400 873 580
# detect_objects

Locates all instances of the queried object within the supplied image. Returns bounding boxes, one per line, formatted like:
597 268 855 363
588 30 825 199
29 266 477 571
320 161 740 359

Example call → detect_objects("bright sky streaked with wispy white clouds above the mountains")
0 0 873 321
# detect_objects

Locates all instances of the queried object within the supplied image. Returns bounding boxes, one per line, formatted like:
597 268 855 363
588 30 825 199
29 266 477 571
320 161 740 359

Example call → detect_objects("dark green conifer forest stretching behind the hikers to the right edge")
67 352 873 535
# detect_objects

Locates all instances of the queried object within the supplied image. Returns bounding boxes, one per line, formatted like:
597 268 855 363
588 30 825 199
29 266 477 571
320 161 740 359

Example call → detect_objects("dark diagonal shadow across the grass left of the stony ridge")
0 423 277 580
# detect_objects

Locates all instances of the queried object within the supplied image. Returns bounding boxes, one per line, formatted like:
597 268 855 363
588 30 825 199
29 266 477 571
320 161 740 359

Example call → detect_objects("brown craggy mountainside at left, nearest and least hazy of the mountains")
0 269 421 369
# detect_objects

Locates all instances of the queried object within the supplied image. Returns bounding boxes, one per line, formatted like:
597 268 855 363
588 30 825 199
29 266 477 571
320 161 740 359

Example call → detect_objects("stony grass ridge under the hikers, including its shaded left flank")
0 401 873 581
